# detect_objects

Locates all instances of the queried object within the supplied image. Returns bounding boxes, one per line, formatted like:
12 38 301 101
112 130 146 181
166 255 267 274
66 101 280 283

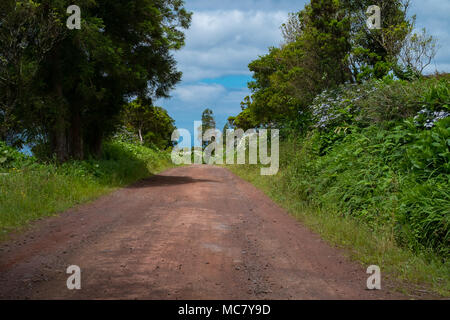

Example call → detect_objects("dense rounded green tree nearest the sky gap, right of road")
238 0 351 127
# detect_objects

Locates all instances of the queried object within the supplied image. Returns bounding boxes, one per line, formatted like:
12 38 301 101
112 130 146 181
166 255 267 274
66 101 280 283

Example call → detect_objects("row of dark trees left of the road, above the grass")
0 0 191 162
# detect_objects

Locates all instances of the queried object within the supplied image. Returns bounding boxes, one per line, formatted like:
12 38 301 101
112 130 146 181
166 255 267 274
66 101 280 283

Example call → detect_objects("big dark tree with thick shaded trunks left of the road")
0 0 191 161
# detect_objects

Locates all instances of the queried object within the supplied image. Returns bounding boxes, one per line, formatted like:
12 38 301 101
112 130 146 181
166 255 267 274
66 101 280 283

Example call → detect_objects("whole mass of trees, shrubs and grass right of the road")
228 0 450 295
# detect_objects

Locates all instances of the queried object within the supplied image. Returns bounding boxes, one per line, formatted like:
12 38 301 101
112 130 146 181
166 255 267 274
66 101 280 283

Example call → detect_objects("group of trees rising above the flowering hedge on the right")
230 0 436 130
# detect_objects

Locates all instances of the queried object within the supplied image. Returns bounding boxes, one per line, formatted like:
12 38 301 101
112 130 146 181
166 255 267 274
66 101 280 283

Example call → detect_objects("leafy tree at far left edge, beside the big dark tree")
0 0 64 147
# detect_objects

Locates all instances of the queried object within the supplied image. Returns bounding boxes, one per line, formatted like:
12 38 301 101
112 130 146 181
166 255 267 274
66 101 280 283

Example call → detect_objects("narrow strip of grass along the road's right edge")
226 165 450 297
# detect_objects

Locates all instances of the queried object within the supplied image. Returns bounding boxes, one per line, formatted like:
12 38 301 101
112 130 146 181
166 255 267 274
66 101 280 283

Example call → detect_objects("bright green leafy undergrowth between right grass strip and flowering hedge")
282 118 450 258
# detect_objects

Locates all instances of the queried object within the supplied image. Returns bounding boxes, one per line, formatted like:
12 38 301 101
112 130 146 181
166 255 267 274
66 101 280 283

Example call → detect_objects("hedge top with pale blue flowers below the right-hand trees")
309 77 450 132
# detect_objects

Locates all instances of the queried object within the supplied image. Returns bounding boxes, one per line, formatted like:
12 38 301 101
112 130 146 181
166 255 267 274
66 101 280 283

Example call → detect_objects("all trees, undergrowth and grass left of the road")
0 0 186 234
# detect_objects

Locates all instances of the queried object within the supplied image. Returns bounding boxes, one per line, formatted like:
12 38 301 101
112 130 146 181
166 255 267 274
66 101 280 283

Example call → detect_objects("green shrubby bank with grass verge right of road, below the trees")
233 75 450 295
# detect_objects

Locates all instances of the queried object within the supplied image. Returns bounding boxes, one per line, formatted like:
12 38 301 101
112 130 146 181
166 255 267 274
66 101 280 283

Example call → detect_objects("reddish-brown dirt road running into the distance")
0 166 404 300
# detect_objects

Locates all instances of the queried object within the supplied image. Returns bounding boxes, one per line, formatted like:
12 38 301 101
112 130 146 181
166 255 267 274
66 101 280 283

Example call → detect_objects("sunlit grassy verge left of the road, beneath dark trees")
0 142 172 240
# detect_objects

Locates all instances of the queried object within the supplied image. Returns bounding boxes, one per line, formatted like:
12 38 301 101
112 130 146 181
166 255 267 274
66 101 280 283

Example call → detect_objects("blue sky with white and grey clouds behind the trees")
157 0 450 139
